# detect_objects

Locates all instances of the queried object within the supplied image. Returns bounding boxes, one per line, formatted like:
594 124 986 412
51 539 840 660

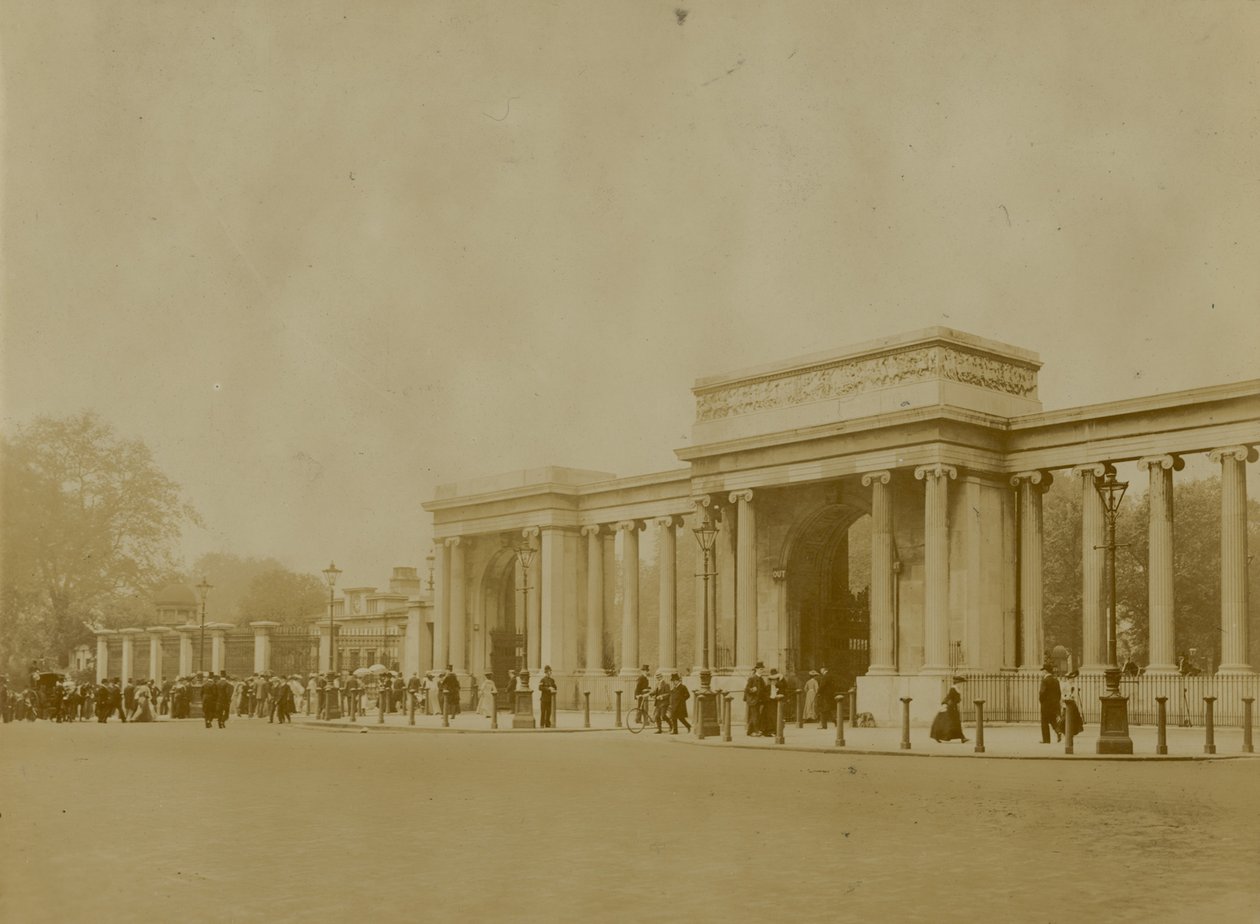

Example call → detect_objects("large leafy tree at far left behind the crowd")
0 412 199 671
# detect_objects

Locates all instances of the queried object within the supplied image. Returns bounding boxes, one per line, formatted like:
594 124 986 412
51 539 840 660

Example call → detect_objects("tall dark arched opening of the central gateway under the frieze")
786 504 871 690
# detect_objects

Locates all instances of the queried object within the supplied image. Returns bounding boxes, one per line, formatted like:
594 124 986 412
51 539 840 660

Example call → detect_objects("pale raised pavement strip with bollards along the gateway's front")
289 711 1256 760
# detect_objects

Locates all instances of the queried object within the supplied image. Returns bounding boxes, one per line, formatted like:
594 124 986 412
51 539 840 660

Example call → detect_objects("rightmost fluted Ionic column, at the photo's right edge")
1208 446 1256 674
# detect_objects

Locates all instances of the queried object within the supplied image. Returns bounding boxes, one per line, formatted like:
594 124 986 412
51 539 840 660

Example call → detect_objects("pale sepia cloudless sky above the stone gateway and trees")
0 0 1260 585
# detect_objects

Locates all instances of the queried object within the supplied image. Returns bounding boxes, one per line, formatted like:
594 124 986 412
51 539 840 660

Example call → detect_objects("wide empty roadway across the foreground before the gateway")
0 716 1260 921
